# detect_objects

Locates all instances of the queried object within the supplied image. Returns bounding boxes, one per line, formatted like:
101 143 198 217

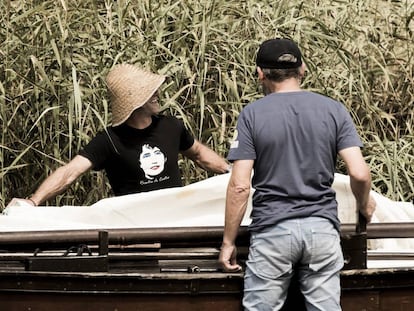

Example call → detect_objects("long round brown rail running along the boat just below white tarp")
0 222 414 247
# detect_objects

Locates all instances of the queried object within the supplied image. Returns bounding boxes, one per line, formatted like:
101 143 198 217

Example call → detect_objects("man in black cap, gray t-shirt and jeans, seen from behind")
219 39 375 311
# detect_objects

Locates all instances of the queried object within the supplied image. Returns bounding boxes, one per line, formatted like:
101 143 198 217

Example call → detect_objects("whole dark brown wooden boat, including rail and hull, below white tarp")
0 223 414 311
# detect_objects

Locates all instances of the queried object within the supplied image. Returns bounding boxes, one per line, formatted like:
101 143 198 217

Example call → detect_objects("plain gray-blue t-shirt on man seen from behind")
228 91 362 231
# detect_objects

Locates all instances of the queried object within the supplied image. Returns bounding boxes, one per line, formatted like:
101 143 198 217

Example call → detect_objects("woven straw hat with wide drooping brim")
106 64 165 126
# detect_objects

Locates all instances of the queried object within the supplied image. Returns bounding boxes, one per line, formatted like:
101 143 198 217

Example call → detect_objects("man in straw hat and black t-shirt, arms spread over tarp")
9 64 229 206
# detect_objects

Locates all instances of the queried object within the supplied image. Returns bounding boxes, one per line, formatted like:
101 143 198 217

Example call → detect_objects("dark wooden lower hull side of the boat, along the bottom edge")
0 268 414 311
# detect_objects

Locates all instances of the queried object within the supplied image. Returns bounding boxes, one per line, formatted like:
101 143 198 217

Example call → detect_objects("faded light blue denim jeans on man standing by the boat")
243 217 344 311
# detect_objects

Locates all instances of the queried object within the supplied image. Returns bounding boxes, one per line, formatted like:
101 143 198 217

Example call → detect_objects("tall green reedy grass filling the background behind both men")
0 0 414 209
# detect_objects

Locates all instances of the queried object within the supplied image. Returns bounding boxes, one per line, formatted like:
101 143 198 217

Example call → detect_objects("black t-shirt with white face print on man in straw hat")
79 116 194 195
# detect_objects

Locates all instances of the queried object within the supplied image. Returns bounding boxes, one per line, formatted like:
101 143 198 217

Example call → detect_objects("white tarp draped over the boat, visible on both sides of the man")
0 174 414 251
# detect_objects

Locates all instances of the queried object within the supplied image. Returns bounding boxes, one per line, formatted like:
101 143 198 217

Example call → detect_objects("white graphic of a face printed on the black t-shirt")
139 144 166 179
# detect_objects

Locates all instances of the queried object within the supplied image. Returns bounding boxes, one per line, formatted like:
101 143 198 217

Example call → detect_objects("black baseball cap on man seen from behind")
256 38 302 69
